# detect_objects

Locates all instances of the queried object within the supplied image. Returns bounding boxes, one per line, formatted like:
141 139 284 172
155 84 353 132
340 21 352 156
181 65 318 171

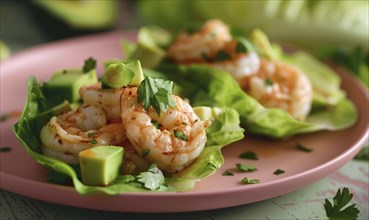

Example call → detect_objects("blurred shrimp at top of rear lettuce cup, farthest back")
167 20 232 63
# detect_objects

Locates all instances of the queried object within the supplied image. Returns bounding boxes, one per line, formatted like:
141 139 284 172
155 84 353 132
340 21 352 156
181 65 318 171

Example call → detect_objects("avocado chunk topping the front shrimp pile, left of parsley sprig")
101 60 145 88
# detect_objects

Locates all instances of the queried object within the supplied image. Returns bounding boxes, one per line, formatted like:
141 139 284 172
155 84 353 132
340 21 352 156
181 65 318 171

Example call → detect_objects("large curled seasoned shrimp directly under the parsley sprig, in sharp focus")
121 87 210 173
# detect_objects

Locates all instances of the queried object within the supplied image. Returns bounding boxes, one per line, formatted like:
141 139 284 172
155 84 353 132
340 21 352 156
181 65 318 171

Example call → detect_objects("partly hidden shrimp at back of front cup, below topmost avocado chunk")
79 84 123 120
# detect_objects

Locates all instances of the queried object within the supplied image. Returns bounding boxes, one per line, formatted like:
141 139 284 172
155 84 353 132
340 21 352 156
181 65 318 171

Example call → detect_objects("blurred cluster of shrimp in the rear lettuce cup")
168 20 313 120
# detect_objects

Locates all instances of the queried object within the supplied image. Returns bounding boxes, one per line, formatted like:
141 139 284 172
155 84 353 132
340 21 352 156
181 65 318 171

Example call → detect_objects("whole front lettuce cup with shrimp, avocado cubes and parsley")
14 58 244 195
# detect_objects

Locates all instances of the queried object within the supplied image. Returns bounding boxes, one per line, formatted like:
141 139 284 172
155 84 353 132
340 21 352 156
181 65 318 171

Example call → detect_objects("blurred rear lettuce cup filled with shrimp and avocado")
122 19 357 138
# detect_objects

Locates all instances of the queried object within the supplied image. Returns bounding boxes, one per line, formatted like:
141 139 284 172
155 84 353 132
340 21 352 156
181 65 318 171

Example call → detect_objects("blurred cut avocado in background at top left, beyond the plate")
33 0 120 30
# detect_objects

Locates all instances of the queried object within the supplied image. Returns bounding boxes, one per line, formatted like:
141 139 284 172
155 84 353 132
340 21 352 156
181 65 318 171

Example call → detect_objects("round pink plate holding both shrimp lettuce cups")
0 32 369 212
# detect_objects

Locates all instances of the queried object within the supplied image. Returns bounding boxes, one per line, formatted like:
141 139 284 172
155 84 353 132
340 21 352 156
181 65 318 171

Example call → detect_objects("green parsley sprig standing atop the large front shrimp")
137 76 175 115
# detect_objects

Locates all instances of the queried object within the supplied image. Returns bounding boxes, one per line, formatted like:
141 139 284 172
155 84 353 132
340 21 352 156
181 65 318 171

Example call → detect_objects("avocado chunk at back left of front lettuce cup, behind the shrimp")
43 69 98 104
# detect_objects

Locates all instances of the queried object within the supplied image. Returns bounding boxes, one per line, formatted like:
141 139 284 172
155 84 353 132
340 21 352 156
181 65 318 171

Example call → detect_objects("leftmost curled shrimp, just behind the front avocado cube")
40 104 126 164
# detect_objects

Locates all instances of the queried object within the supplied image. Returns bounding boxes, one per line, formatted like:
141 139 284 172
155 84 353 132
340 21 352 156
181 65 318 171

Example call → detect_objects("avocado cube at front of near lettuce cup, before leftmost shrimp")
79 146 124 186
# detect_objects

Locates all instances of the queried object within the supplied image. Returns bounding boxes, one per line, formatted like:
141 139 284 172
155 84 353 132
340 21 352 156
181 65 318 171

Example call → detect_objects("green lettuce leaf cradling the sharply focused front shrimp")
13 60 244 195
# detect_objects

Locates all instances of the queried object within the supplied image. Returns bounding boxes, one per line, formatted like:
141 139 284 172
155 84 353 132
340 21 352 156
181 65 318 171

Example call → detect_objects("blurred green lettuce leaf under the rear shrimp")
149 64 357 138
